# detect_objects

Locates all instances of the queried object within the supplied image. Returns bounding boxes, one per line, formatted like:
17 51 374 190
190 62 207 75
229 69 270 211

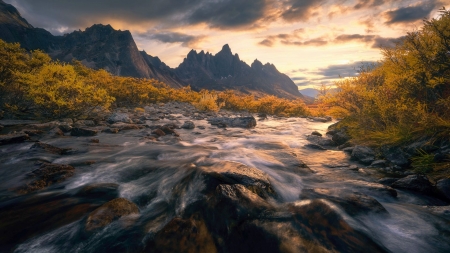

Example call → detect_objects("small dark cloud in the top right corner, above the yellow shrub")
383 0 440 25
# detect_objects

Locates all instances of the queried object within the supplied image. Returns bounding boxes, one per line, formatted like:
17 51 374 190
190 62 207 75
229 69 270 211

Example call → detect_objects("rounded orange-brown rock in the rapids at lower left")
85 198 139 231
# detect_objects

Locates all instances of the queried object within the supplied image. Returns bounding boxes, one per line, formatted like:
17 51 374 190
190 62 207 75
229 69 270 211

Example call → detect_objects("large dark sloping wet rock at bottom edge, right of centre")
289 200 389 252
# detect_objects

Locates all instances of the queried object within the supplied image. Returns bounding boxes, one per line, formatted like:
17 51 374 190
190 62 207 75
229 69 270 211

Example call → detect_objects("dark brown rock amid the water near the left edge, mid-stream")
18 163 75 194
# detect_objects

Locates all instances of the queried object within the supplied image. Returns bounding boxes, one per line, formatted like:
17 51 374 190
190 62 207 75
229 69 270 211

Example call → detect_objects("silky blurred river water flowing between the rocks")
0 115 450 253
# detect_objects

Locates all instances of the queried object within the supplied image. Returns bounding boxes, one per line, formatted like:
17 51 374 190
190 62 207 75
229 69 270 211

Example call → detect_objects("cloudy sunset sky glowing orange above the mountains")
4 0 450 90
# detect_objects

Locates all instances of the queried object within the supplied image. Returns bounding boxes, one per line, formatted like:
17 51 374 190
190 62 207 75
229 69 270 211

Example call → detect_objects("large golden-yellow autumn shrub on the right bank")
323 10 450 145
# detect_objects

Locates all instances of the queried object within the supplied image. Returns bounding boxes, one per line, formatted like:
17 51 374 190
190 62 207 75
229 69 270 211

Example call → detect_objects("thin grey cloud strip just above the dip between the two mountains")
137 32 207 48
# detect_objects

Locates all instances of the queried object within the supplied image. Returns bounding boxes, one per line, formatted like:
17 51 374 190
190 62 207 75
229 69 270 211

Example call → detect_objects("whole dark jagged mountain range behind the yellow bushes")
0 0 303 99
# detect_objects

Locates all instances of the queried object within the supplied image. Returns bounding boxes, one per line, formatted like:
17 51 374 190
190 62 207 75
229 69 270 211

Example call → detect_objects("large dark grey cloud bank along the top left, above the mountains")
6 0 277 30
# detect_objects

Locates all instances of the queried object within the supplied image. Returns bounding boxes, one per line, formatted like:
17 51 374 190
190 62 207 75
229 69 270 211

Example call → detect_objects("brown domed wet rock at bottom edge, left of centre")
148 216 217 253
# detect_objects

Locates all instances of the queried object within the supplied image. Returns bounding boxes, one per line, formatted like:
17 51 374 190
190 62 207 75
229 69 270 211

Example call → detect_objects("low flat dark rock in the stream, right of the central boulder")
300 188 388 216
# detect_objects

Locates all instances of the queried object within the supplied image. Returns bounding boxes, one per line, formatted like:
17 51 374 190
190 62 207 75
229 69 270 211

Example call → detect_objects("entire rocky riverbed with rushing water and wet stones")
0 103 450 253
